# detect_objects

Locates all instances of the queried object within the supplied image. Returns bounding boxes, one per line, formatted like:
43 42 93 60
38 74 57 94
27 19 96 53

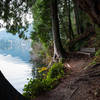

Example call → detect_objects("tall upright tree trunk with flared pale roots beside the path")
51 0 66 59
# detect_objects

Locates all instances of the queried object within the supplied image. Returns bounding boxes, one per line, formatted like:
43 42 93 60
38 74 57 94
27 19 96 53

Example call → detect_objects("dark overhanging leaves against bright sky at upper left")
0 0 32 39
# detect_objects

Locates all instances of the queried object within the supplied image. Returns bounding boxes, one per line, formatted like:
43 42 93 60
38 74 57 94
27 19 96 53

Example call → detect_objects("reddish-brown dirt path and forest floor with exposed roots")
34 55 100 100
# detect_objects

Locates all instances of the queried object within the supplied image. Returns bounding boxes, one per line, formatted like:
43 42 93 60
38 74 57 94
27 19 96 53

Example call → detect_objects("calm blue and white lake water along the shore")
0 30 32 93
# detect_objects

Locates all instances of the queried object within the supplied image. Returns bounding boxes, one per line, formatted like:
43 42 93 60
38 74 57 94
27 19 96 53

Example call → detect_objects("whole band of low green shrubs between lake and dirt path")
23 63 64 98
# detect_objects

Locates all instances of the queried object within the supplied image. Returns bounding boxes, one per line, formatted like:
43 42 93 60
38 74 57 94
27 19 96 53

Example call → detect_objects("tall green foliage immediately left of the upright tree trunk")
31 0 52 47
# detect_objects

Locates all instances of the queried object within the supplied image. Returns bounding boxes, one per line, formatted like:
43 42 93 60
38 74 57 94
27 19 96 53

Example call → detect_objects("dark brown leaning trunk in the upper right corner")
76 0 100 26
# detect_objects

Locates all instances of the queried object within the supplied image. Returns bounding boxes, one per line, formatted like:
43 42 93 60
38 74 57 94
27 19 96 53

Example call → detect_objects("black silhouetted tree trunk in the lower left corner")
0 71 28 100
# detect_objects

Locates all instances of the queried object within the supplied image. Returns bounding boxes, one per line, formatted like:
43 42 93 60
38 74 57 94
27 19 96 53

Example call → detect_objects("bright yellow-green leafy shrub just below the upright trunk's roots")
43 63 64 90
